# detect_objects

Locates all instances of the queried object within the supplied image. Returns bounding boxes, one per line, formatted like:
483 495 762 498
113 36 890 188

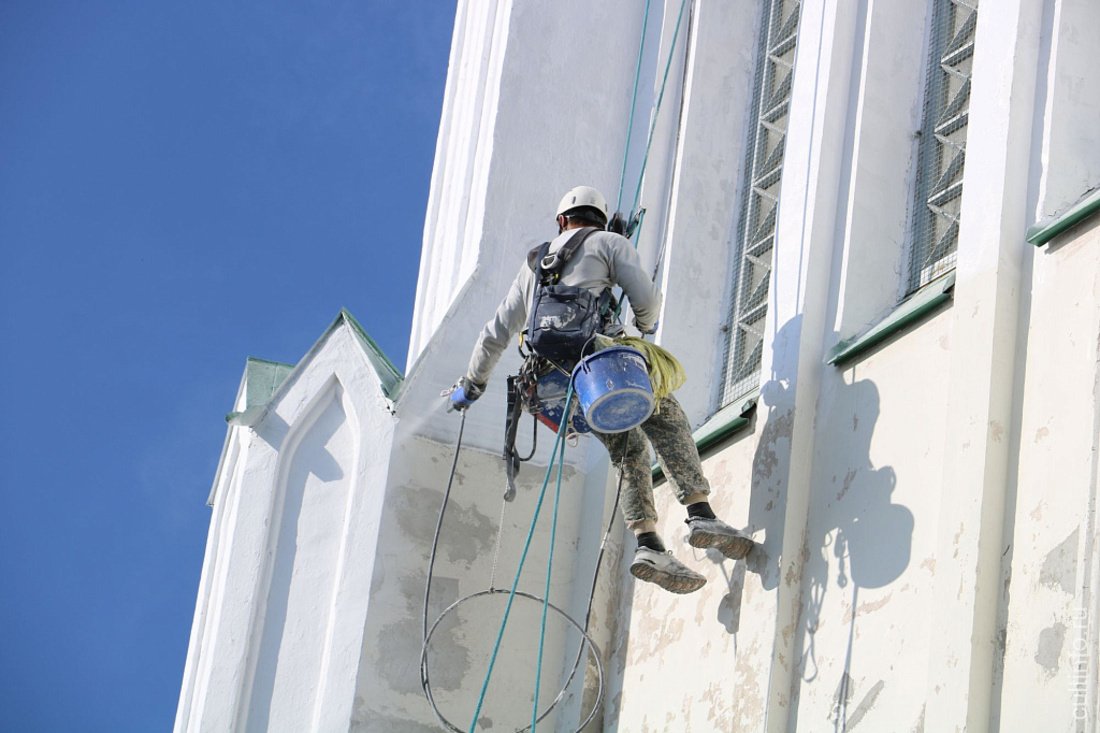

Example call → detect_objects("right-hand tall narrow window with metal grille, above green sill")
906 0 978 293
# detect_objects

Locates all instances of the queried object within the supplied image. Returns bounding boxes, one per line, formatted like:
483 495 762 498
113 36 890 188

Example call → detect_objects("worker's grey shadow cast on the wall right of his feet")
718 318 913 660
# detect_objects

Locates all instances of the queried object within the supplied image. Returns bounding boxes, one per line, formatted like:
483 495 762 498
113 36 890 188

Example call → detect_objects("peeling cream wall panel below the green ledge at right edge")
1001 220 1100 731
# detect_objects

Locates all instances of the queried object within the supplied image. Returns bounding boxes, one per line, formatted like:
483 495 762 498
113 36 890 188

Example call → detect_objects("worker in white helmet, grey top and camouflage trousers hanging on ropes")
450 186 752 593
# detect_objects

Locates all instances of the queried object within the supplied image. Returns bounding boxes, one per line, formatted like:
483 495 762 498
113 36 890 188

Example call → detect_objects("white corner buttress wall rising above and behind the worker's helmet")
407 0 656 381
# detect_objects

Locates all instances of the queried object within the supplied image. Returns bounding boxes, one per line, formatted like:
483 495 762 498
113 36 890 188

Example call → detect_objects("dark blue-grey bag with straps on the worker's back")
527 227 617 367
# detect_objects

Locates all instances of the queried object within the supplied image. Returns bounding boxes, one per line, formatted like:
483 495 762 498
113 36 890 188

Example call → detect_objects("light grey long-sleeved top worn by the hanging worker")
466 231 661 384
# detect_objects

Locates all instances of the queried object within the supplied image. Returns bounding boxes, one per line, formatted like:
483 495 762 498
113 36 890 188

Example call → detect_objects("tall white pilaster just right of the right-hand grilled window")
925 0 1042 733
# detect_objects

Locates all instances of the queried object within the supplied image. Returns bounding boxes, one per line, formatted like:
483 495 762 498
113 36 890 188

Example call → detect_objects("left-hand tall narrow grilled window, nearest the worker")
718 0 800 407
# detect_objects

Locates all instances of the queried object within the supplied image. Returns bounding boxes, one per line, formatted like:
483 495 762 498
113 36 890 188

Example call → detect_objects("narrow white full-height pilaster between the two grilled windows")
762 0 859 733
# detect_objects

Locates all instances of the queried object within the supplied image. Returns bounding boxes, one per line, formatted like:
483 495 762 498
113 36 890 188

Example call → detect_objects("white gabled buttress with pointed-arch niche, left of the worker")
175 317 394 731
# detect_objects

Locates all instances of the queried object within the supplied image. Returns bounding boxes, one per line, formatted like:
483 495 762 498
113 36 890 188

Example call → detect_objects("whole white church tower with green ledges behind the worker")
176 0 1100 733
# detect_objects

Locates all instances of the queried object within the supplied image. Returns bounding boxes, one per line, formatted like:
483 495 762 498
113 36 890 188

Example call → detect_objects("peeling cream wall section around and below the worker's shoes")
604 422 782 731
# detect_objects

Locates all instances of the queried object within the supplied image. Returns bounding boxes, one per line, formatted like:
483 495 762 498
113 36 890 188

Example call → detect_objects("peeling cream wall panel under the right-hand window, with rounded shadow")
784 313 958 731
